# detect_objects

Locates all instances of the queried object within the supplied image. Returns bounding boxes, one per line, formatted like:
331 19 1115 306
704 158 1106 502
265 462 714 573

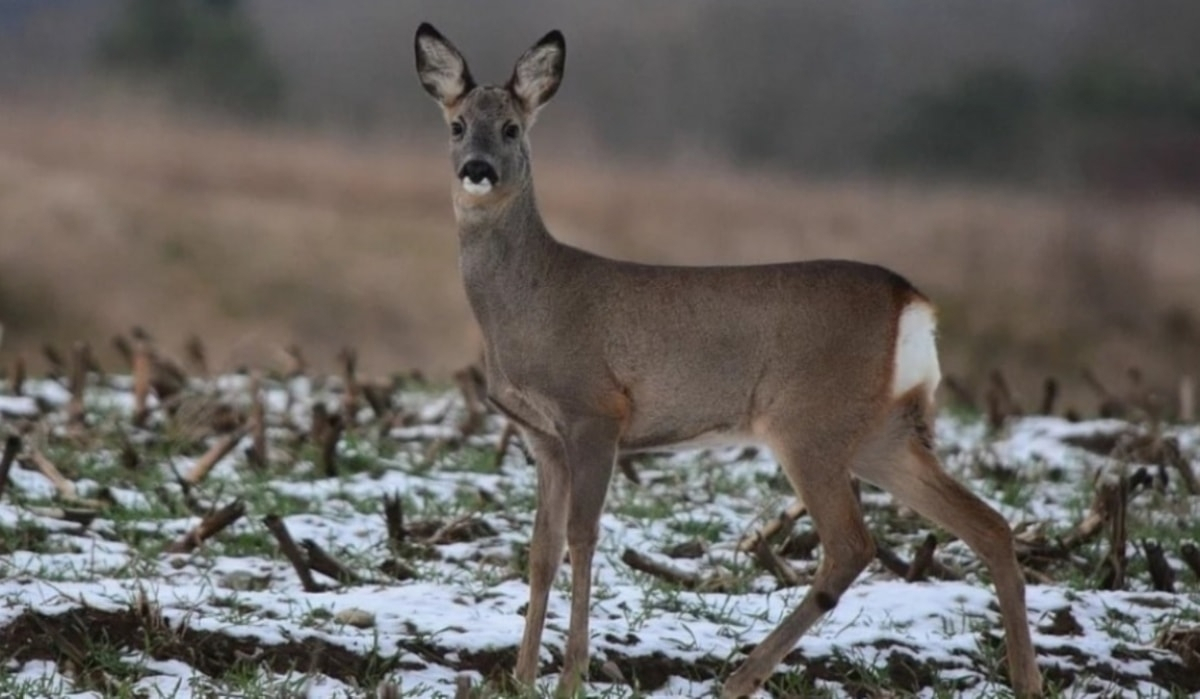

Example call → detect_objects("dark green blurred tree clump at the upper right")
876 59 1200 191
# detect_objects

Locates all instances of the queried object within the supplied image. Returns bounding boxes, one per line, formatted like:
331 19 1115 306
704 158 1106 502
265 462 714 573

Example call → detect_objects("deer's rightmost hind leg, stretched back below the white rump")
856 394 1042 698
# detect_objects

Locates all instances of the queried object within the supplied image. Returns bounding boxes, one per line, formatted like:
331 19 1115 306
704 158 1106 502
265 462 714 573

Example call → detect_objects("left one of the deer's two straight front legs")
514 430 571 685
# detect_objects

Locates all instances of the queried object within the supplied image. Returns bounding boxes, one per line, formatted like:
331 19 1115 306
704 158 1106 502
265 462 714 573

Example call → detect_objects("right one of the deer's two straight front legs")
558 418 620 697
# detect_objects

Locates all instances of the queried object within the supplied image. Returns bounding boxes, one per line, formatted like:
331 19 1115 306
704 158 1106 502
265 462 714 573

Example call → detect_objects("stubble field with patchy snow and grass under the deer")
0 376 1200 698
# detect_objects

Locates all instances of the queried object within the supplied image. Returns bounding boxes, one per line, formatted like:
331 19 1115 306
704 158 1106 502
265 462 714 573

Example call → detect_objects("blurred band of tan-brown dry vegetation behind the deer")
0 100 1200 404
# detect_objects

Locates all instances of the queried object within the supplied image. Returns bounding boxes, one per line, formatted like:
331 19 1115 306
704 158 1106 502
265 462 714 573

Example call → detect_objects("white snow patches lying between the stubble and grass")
0 377 1200 698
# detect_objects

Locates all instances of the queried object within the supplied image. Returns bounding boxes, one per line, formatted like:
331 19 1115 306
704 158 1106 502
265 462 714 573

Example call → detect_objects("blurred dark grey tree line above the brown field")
0 0 1200 189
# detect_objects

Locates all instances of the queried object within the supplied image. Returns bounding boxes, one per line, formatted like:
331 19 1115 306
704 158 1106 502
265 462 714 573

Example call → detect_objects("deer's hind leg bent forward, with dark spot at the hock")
722 440 875 698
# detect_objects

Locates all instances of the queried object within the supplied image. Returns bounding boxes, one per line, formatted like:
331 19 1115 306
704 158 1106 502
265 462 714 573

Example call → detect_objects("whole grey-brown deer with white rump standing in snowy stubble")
414 23 1042 697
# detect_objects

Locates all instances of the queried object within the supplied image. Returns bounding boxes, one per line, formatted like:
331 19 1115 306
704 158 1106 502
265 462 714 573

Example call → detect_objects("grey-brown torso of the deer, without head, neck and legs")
462 220 937 450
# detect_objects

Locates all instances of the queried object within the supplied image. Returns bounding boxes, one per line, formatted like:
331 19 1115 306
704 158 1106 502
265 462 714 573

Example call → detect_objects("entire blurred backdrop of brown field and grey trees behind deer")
0 0 1200 413
